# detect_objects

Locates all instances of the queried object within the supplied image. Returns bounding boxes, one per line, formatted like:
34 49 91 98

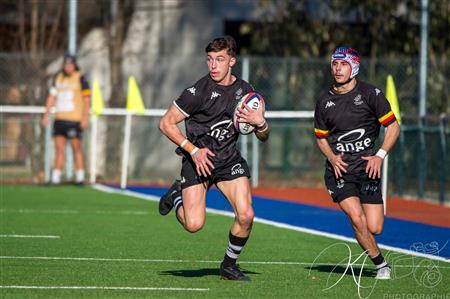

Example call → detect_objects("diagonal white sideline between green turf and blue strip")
92 184 450 263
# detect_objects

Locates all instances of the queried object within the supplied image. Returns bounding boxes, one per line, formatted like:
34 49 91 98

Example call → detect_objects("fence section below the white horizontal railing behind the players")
0 106 450 203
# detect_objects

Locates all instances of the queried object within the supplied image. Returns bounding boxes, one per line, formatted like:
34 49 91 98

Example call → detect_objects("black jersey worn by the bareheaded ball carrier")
174 74 253 167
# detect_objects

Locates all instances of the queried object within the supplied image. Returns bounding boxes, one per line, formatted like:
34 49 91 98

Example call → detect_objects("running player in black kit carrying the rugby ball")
159 36 269 280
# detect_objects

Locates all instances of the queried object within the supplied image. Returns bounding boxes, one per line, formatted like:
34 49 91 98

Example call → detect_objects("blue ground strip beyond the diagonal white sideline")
127 187 450 259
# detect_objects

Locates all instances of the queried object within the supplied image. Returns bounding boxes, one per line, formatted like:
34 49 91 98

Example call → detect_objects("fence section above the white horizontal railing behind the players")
0 52 450 115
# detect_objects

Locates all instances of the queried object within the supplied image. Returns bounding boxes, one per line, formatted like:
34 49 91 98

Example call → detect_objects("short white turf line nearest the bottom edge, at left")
0 285 209 292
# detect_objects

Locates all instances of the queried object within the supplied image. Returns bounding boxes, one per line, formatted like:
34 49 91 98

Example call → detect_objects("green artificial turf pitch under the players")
0 185 450 299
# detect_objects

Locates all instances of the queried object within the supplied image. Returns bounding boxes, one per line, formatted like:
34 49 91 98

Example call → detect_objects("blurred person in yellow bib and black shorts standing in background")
42 55 91 184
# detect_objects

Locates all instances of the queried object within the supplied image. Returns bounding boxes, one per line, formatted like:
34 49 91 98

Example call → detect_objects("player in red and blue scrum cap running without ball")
314 47 400 279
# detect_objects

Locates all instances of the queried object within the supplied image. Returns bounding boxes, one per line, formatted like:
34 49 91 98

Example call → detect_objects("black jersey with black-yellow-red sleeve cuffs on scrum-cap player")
314 81 396 174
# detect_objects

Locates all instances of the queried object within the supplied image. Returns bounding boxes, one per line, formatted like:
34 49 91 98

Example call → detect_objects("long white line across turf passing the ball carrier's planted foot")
0 256 450 269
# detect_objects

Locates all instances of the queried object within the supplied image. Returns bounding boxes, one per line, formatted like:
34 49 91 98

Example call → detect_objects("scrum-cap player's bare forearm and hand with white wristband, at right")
361 121 400 179
